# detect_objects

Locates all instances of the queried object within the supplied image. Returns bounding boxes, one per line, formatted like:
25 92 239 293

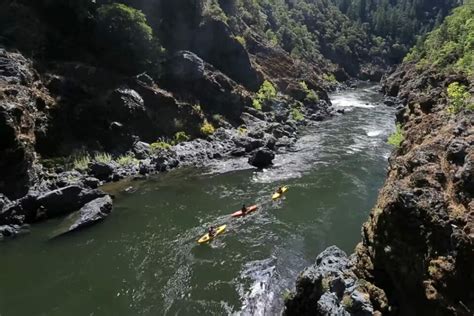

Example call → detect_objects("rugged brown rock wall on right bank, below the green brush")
287 64 474 315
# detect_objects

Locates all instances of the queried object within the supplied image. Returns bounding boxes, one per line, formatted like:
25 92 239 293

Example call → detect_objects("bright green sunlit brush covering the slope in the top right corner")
405 0 474 75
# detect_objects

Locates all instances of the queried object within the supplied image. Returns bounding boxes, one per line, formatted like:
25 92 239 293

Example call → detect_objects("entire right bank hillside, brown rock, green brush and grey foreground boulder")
286 2 474 315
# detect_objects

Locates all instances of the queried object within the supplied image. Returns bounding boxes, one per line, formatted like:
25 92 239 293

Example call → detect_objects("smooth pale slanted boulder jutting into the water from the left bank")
57 195 112 236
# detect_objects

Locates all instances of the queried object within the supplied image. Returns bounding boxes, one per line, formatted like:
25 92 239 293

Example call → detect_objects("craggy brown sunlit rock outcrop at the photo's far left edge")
0 48 50 198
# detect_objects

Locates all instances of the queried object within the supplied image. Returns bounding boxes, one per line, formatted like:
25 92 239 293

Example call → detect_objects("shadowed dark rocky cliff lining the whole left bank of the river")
0 0 331 238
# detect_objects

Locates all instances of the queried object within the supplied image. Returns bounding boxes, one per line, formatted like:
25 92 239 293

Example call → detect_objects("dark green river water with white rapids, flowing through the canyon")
0 85 394 316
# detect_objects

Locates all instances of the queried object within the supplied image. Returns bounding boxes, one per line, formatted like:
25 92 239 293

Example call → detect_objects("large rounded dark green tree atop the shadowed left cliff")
95 3 161 73
